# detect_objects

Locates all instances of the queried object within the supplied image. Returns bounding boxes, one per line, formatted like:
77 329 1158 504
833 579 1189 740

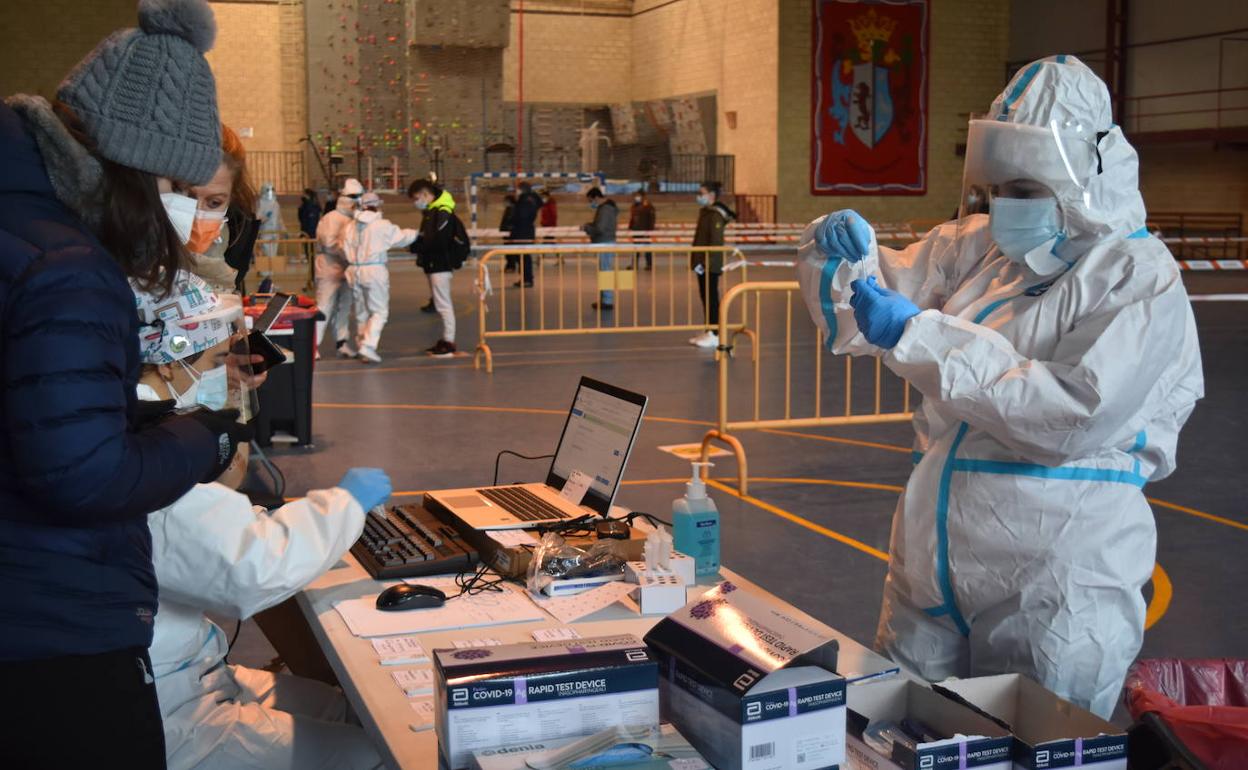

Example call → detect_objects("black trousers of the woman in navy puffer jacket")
0 648 165 770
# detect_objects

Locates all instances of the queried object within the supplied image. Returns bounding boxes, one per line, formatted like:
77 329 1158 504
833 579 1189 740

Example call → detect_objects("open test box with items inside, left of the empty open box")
846 678 1013 770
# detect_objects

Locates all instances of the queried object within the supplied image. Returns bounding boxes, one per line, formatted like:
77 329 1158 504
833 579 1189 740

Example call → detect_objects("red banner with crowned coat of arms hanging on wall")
810 0 930 195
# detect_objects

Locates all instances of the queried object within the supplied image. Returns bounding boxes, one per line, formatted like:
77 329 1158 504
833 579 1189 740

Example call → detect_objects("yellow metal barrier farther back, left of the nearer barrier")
473 243 748 372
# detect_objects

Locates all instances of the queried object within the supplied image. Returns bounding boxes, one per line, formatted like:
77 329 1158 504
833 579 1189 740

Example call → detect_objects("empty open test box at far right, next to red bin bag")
932 674 1127 770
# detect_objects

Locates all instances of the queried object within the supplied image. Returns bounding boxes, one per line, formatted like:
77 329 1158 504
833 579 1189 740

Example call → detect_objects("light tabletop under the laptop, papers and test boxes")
298 554 894 770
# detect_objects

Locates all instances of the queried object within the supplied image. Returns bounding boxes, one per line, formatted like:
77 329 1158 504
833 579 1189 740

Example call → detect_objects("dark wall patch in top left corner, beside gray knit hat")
0 0 139 97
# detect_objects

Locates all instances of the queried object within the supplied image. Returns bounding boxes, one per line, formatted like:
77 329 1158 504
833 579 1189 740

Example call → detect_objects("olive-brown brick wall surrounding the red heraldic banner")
776 0 1010 222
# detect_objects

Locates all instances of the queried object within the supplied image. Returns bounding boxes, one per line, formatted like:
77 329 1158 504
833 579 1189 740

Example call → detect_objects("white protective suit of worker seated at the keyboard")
147 471 381 770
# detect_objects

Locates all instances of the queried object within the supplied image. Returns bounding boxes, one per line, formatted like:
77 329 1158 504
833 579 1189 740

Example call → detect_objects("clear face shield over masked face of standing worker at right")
958 112 1098 275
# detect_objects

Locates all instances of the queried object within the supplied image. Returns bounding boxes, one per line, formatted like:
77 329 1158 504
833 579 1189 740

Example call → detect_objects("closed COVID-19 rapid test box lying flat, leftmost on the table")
433 634 659 770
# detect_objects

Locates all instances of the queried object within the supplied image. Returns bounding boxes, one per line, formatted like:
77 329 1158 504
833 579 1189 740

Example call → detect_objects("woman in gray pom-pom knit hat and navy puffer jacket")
0 0 247 768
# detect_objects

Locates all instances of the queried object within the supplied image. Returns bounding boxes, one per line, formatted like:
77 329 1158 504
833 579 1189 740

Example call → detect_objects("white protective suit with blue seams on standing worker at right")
797 56 1203 718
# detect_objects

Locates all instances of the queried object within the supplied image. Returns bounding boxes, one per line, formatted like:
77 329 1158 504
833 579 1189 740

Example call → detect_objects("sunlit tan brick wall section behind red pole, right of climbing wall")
503 6 633 105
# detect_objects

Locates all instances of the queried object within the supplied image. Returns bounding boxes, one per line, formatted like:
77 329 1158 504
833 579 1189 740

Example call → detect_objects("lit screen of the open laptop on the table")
547 377 645 515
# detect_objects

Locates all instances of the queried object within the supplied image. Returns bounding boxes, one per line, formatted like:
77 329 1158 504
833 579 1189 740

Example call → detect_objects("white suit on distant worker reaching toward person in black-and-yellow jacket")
343 210 417 352
